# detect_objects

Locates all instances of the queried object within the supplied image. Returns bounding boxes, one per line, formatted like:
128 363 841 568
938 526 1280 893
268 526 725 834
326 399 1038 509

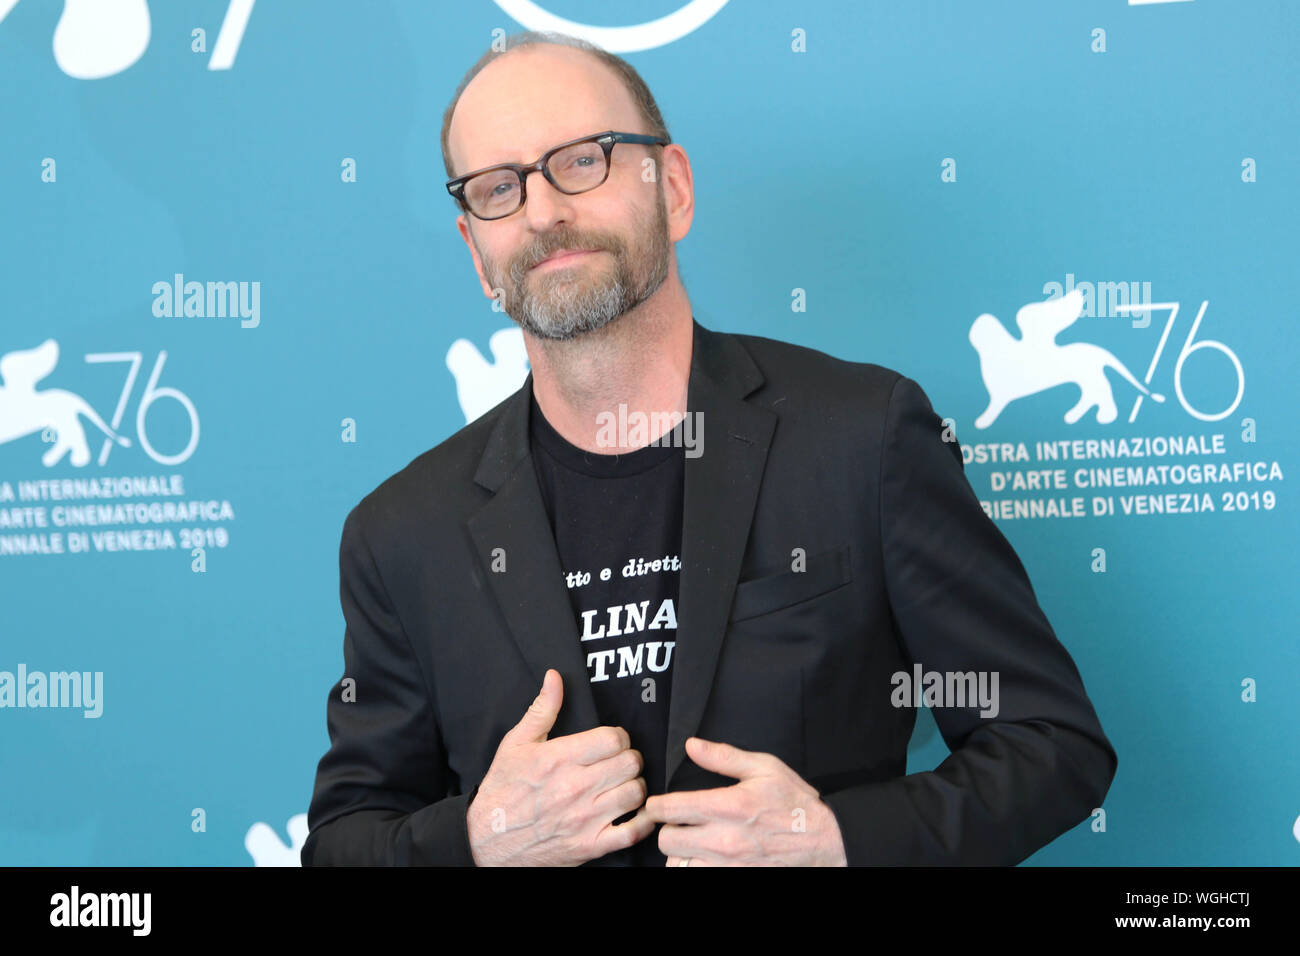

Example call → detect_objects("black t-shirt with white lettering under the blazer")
529 397 685 866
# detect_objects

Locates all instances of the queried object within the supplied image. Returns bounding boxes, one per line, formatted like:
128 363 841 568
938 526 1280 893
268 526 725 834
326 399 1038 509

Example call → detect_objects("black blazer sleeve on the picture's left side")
302 502 477 866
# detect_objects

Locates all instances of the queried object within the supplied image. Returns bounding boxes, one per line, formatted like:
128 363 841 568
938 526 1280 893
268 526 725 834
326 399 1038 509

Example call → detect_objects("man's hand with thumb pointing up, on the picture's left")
467 669 655 866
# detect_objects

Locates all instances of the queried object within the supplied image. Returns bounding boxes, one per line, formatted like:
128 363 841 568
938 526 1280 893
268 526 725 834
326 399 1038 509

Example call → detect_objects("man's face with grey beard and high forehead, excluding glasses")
450 47 673 339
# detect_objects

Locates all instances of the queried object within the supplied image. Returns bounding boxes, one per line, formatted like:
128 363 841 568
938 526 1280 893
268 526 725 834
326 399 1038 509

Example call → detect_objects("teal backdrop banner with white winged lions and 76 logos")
0 0 1300 865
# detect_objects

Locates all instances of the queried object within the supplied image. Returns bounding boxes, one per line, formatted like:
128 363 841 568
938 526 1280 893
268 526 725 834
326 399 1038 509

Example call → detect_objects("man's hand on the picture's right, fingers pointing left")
638 737 848 866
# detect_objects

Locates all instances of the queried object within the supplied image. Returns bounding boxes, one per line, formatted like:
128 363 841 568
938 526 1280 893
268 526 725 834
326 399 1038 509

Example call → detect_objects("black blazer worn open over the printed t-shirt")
302 321 1117 865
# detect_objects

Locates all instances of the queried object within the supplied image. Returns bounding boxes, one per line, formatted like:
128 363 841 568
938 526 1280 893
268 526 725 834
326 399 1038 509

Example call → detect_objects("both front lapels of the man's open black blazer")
468 320 776 790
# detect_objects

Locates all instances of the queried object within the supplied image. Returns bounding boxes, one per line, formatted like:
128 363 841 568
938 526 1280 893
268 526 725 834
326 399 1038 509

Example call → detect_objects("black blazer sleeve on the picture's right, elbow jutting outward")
822 377 1117 866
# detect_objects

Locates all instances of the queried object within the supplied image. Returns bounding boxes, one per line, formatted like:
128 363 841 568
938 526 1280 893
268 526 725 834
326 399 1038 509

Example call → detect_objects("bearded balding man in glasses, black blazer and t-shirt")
302 34 1115 866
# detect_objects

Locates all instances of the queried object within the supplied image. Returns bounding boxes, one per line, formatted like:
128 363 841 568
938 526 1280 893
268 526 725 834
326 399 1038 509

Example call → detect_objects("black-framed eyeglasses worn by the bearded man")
447 130 671 221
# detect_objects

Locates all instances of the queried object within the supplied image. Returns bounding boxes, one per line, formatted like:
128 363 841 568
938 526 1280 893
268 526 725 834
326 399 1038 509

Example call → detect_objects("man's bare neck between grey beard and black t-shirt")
524 281 694 455
